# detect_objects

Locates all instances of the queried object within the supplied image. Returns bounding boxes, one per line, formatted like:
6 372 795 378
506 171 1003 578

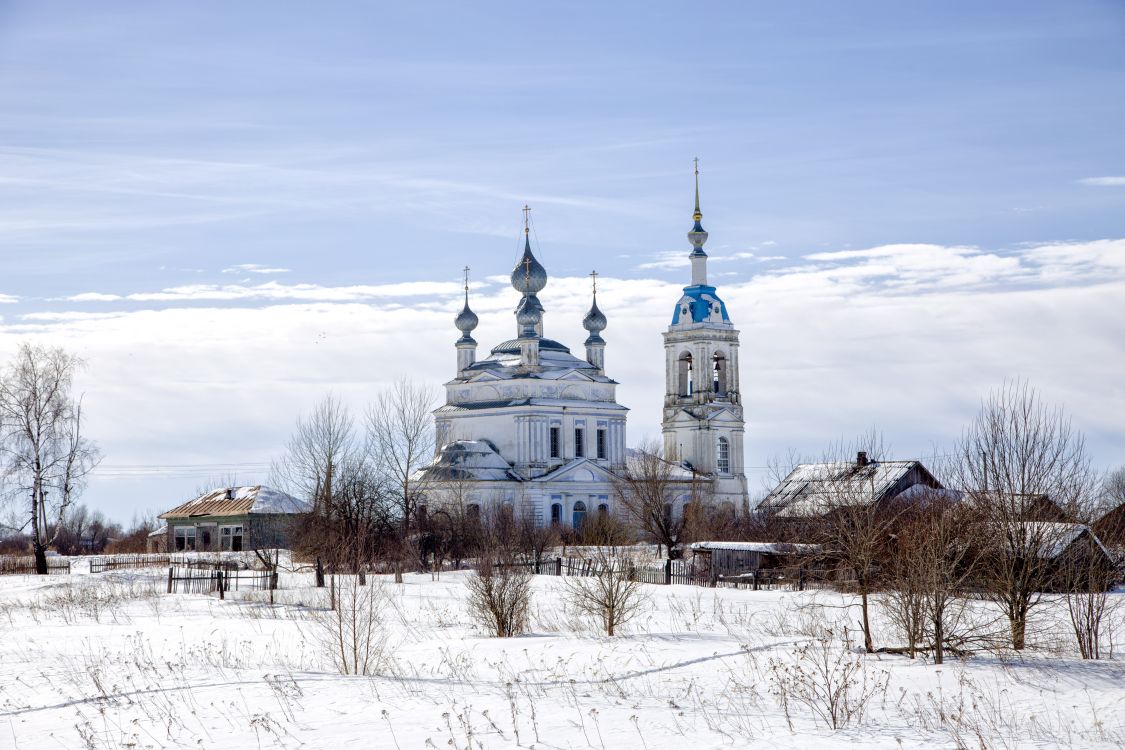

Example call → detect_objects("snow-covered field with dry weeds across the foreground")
0 569 1125 750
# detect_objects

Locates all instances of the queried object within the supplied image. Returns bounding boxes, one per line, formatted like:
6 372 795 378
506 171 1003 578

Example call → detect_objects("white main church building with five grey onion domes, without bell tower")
426 209 628 527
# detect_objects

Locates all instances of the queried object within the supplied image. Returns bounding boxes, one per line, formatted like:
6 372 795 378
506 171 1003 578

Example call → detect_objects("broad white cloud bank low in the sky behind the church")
8 240 1125 518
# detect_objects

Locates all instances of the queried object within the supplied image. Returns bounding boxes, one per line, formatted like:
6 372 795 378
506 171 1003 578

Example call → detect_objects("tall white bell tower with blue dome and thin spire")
662 159 748 513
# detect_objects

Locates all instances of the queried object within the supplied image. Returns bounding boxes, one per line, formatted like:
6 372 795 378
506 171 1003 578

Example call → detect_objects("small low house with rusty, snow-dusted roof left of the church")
160 485 312 552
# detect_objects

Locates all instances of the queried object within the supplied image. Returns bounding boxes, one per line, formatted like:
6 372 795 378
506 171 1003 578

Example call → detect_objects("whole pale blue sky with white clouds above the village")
0 0 1125 521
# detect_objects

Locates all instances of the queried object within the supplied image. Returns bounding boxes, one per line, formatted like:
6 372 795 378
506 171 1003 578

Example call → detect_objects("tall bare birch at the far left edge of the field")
0 343 99 575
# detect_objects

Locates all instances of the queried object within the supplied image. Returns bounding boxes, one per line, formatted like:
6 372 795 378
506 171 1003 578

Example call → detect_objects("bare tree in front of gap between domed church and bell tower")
613 441 702 559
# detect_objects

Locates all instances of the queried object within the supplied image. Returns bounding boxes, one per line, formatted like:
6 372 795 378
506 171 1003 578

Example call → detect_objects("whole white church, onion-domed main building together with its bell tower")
423 171 748 527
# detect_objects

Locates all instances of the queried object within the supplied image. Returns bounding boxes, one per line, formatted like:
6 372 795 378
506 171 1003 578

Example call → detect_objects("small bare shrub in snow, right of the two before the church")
564 546 648 635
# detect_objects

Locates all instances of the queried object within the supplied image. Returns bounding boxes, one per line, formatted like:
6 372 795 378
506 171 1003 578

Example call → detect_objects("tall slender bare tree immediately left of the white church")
367 379 437 584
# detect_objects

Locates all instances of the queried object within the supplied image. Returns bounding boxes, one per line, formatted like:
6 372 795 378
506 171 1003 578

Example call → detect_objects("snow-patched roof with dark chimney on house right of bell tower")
758 461 937 518
